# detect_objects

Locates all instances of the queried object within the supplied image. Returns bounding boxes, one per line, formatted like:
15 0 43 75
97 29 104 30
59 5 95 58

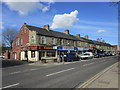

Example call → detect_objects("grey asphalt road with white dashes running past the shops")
2 56 118 88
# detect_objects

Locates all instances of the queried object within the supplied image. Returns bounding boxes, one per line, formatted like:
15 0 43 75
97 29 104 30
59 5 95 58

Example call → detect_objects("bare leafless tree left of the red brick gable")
2 29 18 48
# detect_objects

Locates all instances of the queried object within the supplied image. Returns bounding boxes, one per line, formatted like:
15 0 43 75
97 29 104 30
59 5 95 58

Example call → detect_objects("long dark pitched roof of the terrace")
26 25 111 46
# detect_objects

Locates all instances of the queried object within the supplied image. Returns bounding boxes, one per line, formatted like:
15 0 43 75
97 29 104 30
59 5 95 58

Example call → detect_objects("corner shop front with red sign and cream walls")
21 46 57 61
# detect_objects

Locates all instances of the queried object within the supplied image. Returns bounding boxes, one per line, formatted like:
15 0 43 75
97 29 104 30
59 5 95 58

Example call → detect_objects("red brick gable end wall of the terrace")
11 24 29 59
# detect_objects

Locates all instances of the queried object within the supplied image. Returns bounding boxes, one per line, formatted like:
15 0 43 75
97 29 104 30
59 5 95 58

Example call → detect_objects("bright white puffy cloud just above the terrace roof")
51 10 79 29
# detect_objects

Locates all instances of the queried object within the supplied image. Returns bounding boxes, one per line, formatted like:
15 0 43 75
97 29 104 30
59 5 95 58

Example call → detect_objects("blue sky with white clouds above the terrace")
0 2 118 45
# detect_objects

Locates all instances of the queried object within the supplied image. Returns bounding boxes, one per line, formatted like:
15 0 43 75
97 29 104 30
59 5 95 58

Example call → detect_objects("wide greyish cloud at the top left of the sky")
4 0 52 15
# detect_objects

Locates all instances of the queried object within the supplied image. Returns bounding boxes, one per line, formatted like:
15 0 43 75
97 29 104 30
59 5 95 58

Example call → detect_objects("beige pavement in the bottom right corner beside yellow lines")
77 62 120 88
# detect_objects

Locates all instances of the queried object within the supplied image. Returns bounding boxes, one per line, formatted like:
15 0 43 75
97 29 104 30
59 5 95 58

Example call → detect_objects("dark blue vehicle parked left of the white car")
64 53 80 62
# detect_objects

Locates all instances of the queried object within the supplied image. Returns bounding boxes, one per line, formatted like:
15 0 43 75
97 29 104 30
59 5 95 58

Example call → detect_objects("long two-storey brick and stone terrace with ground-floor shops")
11 23 114 61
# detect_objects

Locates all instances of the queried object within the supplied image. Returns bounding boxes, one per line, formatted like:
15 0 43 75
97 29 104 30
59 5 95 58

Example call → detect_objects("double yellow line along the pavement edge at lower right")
75 62 118 90
